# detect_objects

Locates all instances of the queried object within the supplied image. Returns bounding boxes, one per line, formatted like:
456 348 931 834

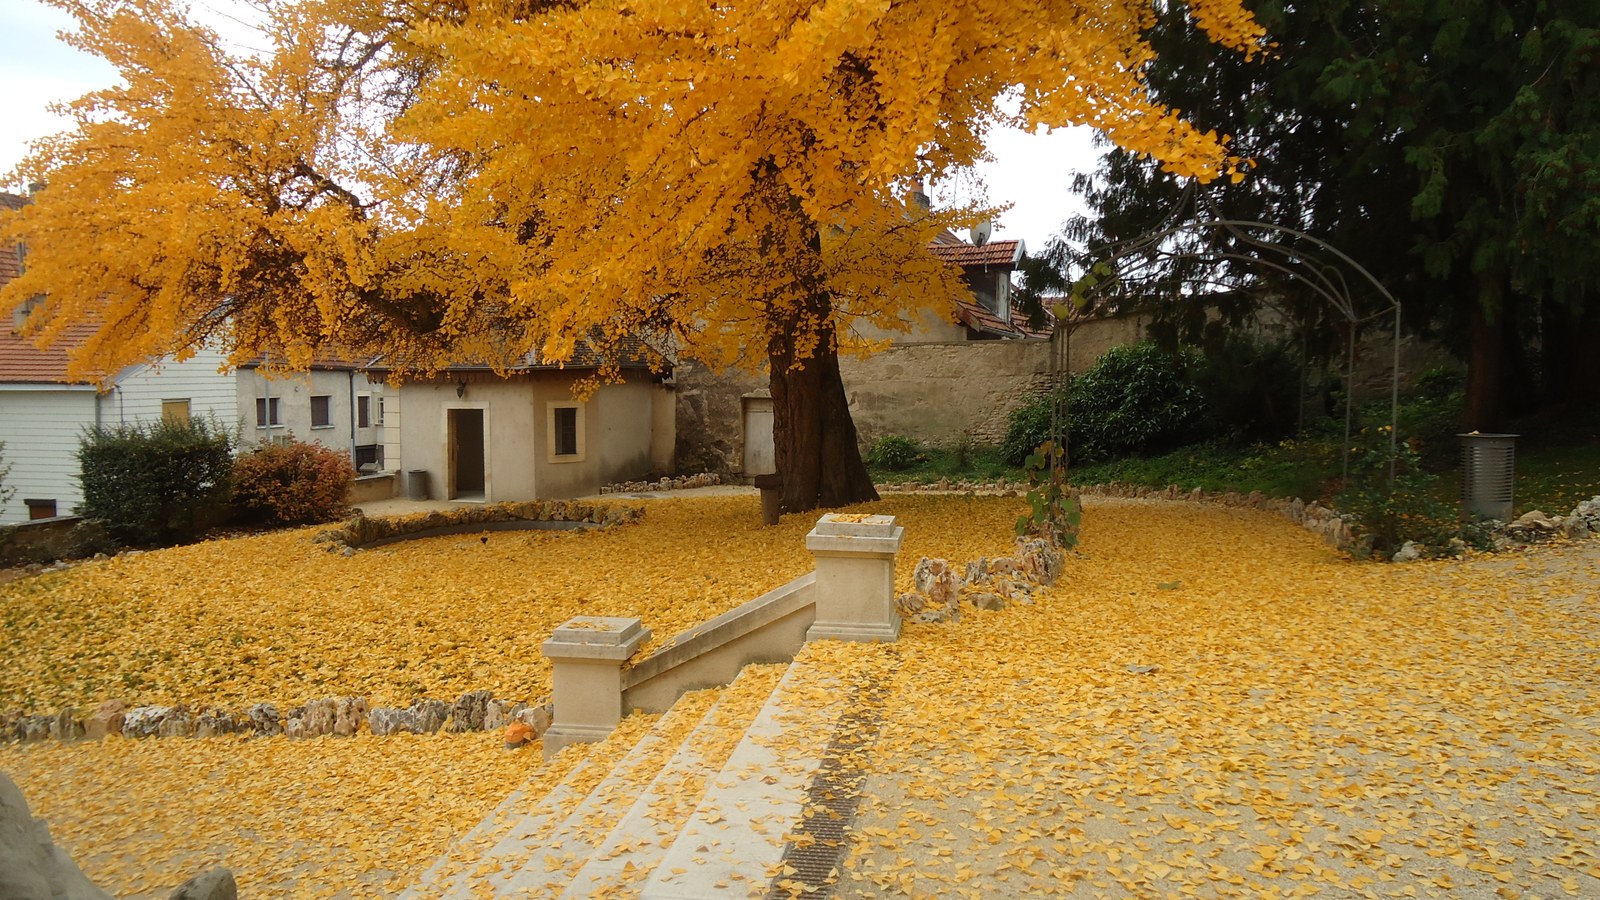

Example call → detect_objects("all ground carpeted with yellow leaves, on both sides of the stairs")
0 496 1600 897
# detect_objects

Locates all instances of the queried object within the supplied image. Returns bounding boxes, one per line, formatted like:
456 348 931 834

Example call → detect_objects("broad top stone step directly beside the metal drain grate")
640 653 850 900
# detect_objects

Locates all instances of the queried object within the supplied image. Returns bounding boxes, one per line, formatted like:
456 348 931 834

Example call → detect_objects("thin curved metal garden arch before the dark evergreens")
1051 203 1400 487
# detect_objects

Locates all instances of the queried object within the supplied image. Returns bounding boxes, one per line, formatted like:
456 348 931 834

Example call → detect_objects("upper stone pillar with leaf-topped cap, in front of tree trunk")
805 512 906 641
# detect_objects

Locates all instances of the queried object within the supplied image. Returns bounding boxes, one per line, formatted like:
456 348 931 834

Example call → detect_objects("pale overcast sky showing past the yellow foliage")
0 0 1098 250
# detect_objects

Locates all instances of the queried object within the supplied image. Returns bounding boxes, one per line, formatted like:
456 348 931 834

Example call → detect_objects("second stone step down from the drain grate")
562 665 787 898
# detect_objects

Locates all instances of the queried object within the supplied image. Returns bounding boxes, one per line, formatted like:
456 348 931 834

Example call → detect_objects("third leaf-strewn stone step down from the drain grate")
402 690 717 900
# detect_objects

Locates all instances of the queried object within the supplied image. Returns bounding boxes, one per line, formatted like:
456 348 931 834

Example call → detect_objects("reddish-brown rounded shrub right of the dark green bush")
234 442 355 525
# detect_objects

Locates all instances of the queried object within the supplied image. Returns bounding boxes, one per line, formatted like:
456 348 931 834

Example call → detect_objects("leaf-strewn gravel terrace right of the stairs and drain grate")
808 498 1600 897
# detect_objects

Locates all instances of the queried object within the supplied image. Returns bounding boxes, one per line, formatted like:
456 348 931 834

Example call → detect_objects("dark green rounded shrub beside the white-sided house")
78 420 234 546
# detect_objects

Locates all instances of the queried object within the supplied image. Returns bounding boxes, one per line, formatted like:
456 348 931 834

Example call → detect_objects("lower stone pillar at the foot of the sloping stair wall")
544 615 650 757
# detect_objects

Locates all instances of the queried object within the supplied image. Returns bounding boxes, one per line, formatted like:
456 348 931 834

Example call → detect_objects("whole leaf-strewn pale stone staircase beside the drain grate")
405 658 851 900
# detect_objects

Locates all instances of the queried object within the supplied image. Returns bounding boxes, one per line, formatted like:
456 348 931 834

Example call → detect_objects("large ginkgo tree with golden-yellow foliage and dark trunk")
0 0 1261 511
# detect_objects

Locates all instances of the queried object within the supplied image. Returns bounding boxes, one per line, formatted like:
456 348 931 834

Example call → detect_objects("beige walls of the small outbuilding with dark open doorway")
396 372 654 503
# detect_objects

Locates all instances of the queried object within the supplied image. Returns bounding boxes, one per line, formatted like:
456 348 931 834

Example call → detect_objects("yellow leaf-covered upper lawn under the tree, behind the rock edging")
0 496 1019 716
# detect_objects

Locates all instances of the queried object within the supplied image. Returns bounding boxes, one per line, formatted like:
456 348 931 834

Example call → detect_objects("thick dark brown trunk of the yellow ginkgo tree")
766 295 878 512
